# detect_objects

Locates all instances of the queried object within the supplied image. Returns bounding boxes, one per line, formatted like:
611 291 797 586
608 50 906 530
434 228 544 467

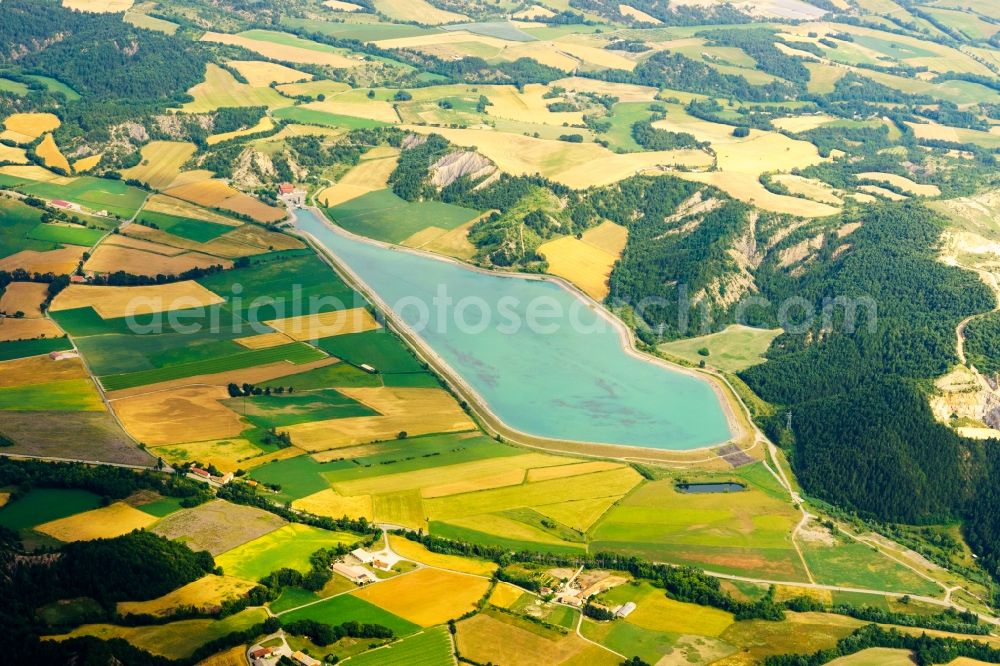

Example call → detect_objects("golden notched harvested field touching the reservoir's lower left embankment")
286 387 476 452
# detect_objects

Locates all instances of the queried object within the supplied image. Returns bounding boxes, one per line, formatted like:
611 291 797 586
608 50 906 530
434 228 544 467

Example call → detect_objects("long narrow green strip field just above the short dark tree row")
100 342 323 391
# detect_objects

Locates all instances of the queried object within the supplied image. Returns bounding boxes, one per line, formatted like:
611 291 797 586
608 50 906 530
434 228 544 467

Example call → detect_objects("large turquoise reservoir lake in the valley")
295 210 732 451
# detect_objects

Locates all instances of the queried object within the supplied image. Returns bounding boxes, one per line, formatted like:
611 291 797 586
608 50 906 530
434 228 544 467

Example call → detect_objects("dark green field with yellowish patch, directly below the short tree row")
223 389 378 428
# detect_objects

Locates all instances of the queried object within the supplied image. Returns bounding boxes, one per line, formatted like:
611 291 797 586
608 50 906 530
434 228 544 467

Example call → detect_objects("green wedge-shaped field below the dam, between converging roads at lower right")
799 537 941 596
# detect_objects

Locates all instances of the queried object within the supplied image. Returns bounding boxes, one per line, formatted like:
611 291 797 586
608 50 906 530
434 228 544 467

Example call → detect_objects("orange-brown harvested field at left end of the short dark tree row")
111 386 246 446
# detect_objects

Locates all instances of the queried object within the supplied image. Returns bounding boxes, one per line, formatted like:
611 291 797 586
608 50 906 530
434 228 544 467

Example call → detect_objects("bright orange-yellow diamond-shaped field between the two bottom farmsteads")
352 569 490 627
